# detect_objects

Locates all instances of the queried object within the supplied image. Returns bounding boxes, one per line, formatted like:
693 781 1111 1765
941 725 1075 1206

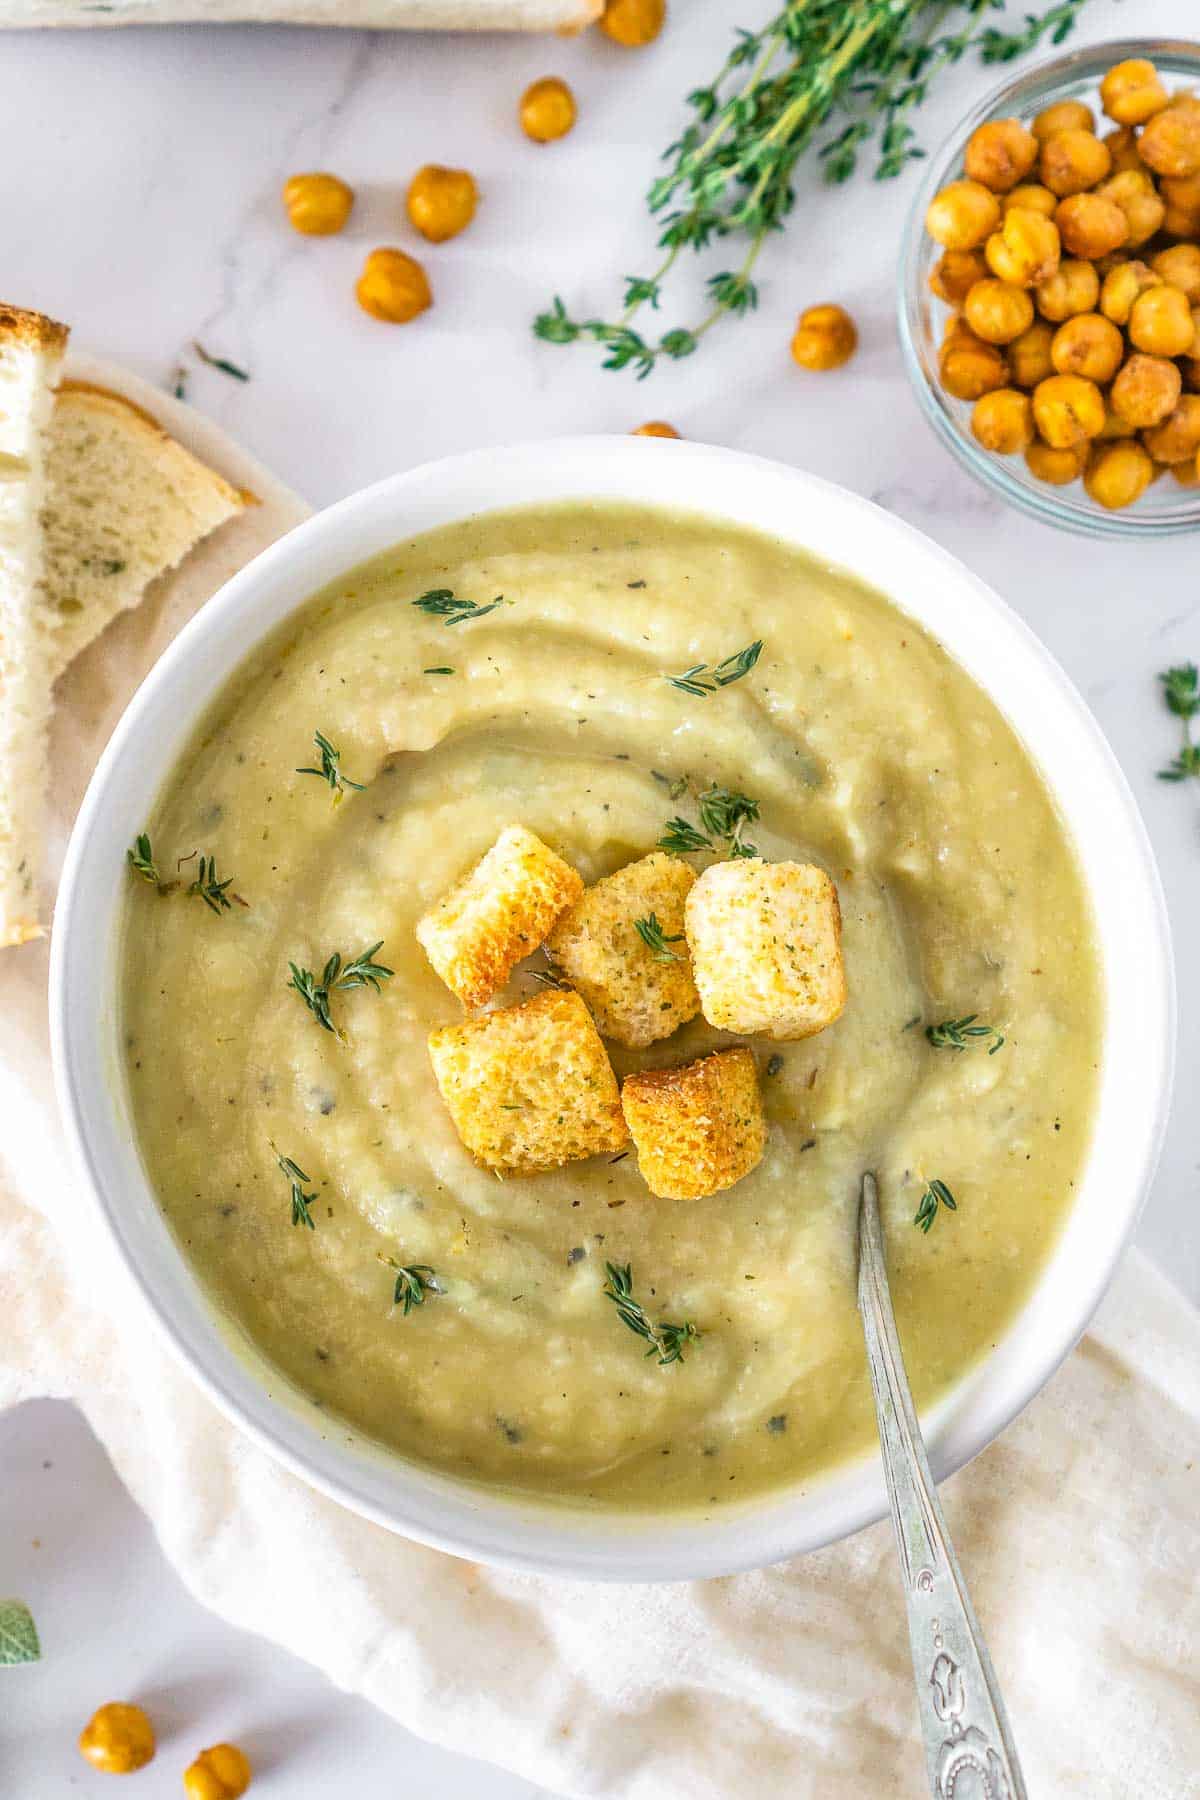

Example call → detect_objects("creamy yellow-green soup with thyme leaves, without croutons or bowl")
122 504 1103 1510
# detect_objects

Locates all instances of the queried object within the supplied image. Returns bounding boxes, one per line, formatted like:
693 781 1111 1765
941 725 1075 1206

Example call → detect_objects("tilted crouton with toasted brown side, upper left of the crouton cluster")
417 824 583 1006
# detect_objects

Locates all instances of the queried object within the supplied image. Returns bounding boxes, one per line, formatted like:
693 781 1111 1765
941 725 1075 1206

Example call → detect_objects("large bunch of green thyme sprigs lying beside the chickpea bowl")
533 0 1085 380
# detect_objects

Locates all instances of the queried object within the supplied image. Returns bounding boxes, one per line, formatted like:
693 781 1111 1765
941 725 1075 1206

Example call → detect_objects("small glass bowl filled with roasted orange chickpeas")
900 40 1200 536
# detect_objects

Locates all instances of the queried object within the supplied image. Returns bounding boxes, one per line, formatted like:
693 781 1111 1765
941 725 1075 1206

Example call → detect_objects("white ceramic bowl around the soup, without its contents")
50 437 1175 1580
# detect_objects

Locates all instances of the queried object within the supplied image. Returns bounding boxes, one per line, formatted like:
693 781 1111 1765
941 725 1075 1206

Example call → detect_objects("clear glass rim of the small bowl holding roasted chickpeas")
896 38 1200 540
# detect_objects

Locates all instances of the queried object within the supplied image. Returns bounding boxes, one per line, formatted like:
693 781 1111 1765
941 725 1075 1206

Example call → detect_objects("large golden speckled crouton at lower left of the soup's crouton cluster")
430 988 630 1175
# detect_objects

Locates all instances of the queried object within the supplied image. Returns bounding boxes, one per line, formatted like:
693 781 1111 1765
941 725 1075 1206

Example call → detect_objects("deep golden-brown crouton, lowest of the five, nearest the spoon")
621 1046 766 1201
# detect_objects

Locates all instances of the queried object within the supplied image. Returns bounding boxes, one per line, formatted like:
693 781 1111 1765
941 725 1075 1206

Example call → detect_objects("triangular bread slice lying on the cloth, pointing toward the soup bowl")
41 382 248 679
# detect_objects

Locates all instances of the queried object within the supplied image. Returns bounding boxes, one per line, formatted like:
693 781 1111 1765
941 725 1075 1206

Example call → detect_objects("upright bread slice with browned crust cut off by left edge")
0 306 67 945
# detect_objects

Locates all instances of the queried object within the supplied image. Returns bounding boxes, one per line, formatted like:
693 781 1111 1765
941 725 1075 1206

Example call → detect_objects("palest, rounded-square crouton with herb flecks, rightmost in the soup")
684 857 846 1039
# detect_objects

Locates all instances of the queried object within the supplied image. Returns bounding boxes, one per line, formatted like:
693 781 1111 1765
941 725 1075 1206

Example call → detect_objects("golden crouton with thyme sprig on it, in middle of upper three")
545 850 700 1044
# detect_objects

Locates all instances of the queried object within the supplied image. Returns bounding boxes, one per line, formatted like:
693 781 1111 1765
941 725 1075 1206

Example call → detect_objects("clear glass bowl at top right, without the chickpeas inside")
900 38 1200 538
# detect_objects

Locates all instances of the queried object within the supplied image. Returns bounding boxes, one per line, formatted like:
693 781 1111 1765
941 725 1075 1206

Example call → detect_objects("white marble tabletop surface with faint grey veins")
0 0 1200 1800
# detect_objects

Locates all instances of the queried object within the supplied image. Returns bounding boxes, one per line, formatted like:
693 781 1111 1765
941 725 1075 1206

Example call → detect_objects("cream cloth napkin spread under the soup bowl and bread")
0 364 1200 1800
